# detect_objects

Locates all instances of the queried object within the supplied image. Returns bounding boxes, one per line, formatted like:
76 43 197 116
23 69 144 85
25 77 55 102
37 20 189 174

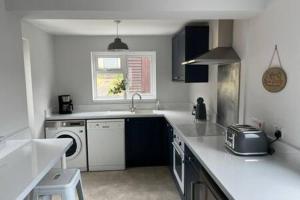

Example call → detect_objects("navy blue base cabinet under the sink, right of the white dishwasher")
125 117 168 167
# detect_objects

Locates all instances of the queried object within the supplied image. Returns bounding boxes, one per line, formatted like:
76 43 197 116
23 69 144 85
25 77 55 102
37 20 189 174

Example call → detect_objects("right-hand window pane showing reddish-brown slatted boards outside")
127 56 151 93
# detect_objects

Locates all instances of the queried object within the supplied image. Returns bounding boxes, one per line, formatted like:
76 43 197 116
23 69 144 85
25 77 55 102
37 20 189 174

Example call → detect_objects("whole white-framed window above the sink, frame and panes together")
92 52 156 101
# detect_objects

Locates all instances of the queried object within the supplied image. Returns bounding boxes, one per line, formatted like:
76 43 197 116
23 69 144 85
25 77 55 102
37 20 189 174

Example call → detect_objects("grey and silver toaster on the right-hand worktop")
225 124 269 156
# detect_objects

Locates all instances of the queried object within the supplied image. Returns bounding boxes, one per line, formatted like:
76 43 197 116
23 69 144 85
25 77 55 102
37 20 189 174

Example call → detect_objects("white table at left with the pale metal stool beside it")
0 139 72 200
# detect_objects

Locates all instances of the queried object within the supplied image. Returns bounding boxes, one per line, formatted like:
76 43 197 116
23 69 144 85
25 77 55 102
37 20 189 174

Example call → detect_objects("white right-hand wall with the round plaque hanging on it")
234 0 300 148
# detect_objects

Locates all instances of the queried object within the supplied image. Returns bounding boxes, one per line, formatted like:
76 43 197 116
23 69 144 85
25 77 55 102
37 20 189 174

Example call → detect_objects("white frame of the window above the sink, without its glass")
91 51 157 103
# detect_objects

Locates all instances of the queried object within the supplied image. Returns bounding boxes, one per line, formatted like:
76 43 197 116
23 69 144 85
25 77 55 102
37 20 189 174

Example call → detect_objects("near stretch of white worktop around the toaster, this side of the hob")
186 136 300 200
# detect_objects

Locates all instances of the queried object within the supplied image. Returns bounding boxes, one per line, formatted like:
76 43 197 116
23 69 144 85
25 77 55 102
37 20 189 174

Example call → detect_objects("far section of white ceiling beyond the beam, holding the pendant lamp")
30 19 193 35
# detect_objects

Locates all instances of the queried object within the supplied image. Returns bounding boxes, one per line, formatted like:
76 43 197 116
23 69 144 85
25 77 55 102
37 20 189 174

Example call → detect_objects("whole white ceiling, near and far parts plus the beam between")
19 0 270 35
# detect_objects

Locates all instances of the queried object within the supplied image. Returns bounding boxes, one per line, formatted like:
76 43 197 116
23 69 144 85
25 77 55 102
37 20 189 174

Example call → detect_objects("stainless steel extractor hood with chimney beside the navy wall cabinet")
182 20 241 65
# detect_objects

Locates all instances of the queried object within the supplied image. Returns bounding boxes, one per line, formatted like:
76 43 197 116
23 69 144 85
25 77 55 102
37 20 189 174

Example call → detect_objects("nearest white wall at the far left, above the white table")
0 0 28 138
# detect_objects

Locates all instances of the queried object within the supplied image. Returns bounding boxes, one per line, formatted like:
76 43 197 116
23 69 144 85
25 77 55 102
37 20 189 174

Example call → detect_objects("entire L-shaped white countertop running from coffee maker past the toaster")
47 110 300 200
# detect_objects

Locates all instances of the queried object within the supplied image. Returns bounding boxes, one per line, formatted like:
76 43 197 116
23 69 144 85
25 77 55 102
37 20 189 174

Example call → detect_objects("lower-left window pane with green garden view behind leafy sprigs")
96 72 124 98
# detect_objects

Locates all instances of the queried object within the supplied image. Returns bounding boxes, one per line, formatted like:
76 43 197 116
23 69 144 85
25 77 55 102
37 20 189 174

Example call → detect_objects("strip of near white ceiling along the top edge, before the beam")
5 0 270 14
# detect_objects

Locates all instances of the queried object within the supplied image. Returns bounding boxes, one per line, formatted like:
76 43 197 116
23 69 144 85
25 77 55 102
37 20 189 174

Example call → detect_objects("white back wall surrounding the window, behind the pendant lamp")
54 36 189 109
